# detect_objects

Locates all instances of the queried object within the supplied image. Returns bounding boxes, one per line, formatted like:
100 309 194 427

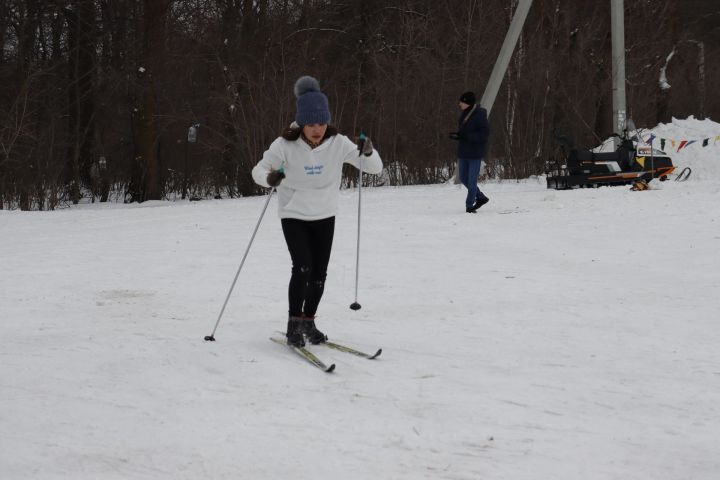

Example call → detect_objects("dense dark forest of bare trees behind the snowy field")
0 0 720 209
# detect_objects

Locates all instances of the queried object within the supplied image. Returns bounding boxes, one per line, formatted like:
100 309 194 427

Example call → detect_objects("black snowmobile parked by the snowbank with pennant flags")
545 122 675 190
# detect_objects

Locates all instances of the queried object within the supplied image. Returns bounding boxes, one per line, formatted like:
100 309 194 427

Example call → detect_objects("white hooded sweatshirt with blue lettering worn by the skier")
252 134 382 220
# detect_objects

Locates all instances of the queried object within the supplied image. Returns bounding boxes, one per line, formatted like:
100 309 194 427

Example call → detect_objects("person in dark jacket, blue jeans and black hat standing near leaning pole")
450 92 490 213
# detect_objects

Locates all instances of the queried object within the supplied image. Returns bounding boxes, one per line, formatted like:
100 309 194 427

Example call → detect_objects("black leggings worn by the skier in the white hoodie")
281 217 335 317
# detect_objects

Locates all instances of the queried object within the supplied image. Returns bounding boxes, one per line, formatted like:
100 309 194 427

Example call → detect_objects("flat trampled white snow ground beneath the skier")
0 118 720 480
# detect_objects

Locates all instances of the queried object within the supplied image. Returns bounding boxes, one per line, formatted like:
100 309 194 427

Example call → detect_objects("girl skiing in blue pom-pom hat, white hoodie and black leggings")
252 76 382 347
